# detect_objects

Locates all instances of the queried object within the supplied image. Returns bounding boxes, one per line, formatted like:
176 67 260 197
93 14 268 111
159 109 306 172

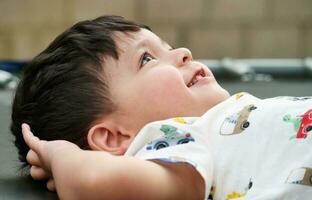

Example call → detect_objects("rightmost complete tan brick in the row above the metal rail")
247 26 300 58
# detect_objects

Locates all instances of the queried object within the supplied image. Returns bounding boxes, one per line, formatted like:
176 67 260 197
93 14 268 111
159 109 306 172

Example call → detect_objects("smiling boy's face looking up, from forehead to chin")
105 29 229 134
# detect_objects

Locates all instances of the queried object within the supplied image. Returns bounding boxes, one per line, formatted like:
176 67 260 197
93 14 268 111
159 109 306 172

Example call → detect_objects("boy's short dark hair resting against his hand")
11 16 149 168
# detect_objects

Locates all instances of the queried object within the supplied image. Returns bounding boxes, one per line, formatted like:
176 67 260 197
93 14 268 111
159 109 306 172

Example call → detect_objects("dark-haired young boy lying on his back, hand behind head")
12 16 312 199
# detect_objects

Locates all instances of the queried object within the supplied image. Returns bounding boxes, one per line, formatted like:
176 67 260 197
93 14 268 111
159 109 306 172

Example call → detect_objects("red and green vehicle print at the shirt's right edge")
283 109 312 139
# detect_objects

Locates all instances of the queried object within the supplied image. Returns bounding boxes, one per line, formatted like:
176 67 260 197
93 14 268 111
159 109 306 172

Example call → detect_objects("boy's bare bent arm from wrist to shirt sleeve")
52 150 204 200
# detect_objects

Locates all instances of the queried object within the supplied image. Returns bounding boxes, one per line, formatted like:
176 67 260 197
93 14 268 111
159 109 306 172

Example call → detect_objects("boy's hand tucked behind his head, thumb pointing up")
22 124 79 191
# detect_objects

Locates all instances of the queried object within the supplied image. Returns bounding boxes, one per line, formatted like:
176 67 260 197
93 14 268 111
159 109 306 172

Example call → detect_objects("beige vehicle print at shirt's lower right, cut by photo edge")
286 167 312 186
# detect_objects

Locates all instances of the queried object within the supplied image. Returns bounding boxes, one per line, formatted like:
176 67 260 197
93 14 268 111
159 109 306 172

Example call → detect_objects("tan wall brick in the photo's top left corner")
0 0 64 27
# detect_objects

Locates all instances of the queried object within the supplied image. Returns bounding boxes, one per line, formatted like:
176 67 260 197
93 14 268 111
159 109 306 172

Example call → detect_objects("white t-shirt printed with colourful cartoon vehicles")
126 93 312 200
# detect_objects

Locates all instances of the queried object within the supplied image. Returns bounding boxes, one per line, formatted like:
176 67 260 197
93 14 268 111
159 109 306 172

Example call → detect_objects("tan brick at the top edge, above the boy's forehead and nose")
145 0 201 23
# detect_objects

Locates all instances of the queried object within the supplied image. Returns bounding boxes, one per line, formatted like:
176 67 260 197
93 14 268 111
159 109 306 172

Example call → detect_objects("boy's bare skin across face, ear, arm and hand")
22 29 229 200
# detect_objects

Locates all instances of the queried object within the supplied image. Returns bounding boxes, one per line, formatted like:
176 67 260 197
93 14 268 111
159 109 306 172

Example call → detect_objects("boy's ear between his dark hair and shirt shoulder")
88 123 132 155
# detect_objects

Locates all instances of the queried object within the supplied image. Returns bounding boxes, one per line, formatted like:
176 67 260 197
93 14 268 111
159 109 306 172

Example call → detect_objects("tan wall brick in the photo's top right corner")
272 0 312 21
